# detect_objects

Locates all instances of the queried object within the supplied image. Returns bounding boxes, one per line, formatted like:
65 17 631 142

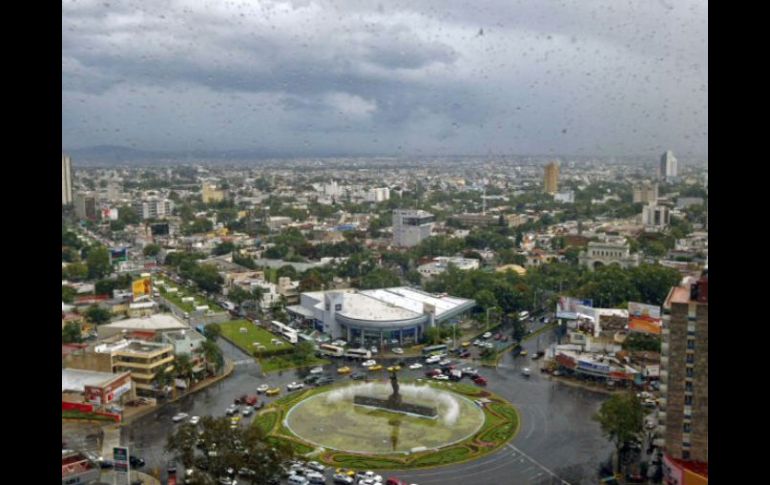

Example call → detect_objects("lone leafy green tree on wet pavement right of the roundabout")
593 392 644 470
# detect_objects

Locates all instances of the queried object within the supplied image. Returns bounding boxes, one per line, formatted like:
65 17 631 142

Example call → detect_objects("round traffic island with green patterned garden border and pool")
253 380 519 469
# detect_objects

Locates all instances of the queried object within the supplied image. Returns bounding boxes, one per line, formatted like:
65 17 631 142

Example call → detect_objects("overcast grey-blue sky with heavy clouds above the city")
62 0 708 157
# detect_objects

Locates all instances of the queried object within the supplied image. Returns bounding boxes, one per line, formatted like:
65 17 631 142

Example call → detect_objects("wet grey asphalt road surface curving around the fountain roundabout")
111 324 612 485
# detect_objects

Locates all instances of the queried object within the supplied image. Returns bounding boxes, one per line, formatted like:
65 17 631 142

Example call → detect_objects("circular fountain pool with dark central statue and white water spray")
284 368 485 454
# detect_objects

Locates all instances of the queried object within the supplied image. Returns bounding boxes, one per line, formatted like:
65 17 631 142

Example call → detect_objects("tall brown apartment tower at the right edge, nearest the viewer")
658 270 709 466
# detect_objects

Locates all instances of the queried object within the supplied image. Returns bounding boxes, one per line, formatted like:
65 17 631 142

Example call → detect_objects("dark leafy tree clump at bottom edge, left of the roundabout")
166 416 294 485
